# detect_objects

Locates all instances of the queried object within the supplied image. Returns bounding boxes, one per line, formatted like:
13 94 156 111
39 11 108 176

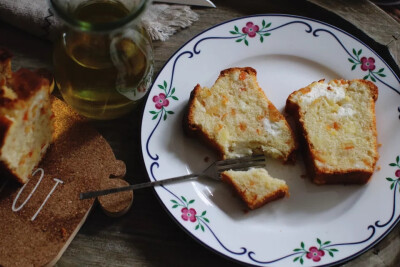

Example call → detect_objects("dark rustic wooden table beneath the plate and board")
0 0 400 266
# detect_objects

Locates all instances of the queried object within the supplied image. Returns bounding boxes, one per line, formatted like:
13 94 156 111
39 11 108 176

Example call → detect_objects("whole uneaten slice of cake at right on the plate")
286 80 379 184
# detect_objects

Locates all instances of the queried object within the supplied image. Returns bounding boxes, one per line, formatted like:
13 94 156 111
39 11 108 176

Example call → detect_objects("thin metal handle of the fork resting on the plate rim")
79 173 201 199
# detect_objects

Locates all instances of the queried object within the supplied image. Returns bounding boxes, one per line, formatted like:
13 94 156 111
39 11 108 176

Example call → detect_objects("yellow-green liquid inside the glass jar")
54 1 149 119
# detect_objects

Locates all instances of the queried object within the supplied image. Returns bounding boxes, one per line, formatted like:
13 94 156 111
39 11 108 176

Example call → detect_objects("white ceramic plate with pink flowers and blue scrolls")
142 15 400 266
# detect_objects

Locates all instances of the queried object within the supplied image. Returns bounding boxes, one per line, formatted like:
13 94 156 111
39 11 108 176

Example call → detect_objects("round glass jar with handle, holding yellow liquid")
49 0 153 119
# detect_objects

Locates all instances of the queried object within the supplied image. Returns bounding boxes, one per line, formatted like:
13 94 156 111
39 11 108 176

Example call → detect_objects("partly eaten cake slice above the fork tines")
184 67 296 161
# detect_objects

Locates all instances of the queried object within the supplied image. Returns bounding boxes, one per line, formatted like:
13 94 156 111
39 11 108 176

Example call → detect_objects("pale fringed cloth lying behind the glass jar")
0 0 198 41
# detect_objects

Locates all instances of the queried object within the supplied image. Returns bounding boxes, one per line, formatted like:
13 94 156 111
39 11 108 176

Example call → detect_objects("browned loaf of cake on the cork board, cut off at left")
0 48 53 183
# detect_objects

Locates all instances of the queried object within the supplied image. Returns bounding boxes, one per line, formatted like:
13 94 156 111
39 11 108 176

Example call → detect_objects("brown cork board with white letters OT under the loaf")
0 98 133 266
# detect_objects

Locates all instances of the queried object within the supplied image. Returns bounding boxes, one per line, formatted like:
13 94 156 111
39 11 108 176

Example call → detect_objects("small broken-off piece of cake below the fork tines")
221 168 289 209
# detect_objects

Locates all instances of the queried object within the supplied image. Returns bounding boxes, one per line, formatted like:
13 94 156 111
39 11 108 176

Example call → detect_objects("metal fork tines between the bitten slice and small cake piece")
216 154 265 172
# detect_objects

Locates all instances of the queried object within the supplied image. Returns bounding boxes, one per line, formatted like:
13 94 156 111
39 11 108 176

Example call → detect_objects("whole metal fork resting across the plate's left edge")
79 155 265 199
